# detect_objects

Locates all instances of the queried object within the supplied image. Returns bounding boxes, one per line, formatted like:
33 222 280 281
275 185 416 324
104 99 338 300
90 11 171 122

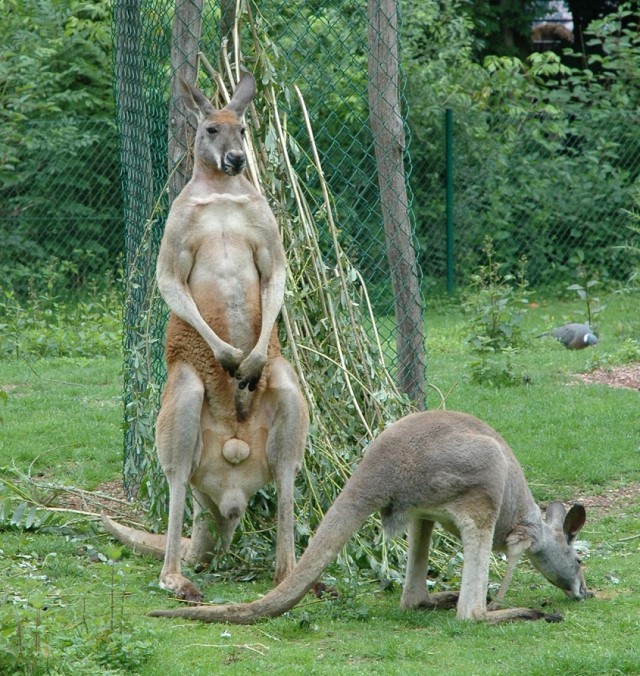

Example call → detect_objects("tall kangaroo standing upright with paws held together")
103 73 308 601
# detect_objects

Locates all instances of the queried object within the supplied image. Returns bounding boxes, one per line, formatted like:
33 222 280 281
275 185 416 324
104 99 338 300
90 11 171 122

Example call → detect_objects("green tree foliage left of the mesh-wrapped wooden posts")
0 0 119 288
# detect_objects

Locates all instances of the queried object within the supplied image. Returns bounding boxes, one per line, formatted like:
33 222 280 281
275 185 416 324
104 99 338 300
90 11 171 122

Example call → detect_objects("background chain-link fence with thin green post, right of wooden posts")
412 110 640 292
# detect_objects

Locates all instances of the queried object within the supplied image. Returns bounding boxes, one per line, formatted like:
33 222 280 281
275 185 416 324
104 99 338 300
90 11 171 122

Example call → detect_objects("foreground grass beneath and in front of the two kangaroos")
0 516 640 675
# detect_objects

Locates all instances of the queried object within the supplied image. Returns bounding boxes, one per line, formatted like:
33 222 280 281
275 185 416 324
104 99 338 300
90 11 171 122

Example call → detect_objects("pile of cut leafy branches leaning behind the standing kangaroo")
184 11 420 577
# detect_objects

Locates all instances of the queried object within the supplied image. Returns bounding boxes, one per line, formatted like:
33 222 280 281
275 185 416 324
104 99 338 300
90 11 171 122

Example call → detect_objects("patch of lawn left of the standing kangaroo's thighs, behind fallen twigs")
0 356 123 490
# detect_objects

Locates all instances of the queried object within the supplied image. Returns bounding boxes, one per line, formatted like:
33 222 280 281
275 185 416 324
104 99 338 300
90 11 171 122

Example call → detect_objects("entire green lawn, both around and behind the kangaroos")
0 295 640 676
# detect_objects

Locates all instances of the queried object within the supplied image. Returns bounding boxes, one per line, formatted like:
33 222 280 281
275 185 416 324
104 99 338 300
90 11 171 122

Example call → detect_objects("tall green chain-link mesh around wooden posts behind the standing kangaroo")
114 0 424 500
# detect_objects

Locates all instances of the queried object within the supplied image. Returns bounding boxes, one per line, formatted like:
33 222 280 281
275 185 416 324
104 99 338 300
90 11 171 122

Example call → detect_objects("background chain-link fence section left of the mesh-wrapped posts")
0 119 124 295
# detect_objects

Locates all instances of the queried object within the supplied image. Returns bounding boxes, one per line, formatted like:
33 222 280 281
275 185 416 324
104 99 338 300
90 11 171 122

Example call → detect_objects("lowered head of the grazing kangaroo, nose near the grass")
528 502 591 601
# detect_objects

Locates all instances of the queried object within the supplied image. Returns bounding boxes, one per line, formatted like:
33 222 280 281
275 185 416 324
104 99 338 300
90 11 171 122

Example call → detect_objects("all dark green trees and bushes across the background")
0 0 640 301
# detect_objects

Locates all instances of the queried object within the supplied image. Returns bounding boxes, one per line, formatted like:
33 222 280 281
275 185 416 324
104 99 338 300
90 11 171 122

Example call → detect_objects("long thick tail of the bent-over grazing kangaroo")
149 483 380 624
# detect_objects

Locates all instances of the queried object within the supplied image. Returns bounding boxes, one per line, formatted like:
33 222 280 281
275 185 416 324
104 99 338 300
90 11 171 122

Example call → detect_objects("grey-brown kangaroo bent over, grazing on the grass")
151 411 590 624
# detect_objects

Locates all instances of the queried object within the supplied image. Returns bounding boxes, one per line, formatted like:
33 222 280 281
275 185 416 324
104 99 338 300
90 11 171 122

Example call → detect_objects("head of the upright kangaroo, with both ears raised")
180 72 256 176
